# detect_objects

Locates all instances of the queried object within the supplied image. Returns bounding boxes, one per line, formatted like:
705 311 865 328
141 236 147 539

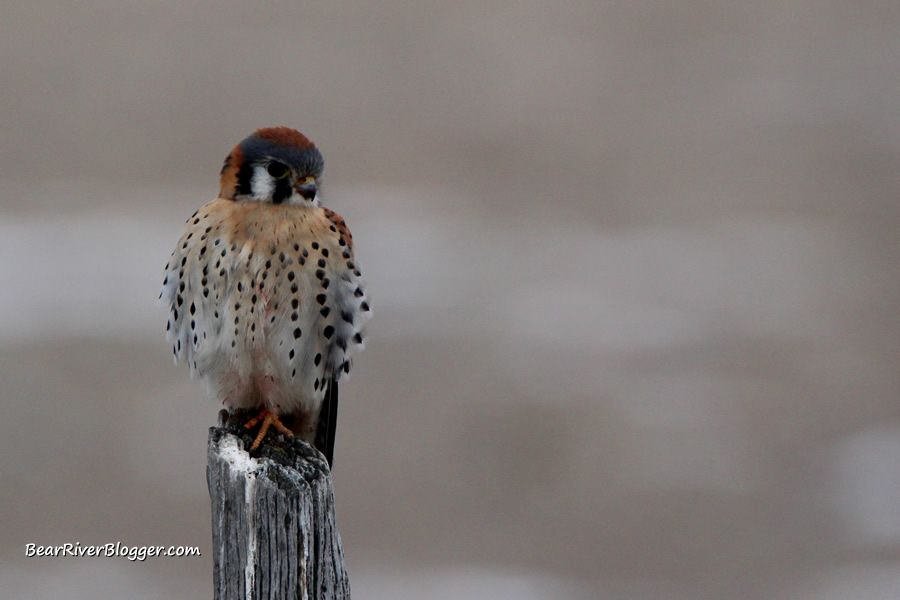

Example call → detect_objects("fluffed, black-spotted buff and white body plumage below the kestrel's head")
160 198 371 410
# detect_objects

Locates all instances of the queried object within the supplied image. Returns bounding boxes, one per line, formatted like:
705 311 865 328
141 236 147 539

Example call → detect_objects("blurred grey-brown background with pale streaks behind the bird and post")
0 0 900 600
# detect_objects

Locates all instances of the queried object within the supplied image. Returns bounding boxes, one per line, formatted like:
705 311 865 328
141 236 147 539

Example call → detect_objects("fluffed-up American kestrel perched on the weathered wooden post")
160 127 371 465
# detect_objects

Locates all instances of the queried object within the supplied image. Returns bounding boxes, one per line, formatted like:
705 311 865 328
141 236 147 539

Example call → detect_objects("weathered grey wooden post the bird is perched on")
206 411 350 600
